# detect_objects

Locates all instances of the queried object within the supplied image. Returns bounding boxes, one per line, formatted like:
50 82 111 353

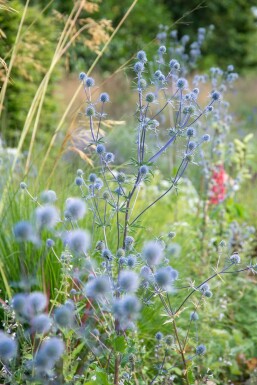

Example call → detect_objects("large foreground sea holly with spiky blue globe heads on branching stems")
0 46 256 385
